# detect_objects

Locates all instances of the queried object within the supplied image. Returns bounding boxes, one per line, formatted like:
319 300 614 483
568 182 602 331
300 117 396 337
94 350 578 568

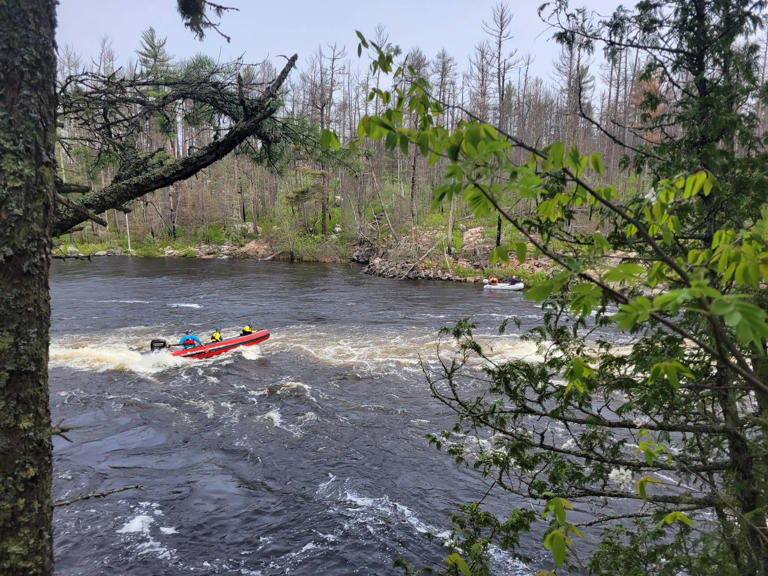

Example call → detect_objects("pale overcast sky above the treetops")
57 0 633 80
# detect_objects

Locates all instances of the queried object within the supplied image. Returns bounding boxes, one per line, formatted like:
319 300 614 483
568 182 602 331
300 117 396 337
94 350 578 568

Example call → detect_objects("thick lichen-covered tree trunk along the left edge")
0 0 56 576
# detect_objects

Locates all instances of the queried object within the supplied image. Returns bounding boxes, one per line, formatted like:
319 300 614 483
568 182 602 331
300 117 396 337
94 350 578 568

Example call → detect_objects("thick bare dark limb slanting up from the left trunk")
52 54 298 236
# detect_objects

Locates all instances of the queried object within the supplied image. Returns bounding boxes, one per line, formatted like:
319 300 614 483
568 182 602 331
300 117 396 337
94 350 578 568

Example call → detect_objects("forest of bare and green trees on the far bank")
55 3 688 274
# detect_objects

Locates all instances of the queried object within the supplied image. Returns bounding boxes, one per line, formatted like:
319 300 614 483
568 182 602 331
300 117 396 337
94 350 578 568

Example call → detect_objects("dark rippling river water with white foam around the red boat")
50 257 540 576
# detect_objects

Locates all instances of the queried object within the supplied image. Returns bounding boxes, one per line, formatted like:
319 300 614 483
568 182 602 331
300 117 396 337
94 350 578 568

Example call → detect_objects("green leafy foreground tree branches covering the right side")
352 0 768 575
